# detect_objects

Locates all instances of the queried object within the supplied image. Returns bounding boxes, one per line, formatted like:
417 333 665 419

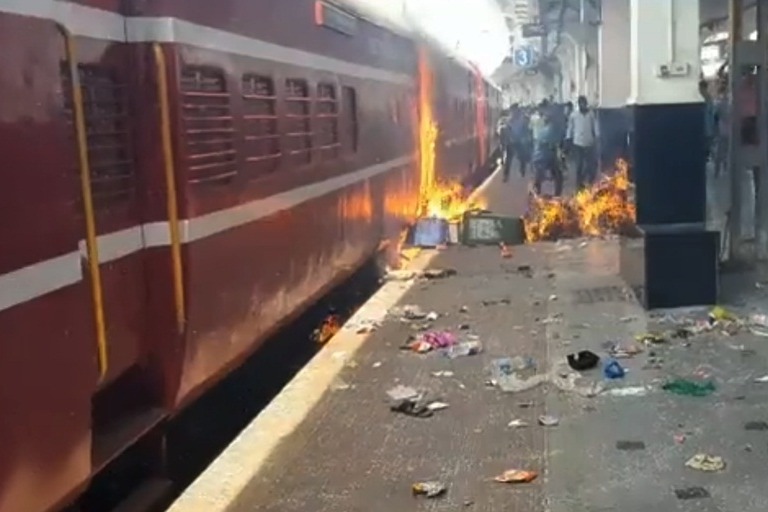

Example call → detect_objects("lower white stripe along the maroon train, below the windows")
0 156 414 311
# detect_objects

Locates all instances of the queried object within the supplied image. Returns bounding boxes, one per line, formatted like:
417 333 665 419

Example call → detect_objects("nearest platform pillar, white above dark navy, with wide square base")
621 0 719 308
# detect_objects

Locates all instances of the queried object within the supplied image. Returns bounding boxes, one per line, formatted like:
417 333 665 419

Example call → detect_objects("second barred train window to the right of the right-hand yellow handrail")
242 74 281 179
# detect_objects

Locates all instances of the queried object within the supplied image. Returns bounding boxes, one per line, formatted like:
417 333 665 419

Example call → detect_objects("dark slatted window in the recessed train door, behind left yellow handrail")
62 64 136 210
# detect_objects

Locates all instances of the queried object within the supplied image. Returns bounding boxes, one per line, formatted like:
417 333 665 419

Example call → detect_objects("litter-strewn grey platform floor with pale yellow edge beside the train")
169 168 768 512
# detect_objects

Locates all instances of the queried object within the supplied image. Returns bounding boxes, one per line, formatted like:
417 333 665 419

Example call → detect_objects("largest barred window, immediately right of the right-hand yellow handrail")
180 66 237 184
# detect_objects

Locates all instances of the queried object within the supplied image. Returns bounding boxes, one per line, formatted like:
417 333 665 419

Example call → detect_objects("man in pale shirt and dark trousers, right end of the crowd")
566 96 599 189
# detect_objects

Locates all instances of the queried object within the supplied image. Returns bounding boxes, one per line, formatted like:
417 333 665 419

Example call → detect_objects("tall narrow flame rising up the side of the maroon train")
418 49 482 220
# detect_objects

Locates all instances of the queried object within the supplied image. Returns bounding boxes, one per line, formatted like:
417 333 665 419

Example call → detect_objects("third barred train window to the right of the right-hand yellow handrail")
285 78 312 165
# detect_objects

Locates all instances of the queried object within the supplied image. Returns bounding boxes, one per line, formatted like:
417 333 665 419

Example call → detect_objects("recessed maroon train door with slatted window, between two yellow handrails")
62 30 163 471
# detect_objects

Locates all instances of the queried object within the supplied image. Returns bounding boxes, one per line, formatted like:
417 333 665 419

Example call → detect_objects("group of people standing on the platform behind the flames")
499 96 599 196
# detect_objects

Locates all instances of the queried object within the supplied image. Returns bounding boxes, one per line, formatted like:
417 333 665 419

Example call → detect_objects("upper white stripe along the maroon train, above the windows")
0 0 414 84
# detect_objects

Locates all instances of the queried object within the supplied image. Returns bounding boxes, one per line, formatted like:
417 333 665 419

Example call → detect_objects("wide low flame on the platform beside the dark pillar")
525 160 635 242
